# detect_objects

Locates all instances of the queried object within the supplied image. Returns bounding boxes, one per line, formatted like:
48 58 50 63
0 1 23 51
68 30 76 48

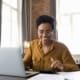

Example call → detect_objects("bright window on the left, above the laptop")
1 0 21 47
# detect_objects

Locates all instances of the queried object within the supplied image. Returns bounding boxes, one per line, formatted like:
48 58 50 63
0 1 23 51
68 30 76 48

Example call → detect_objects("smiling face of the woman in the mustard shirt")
38 23 53 42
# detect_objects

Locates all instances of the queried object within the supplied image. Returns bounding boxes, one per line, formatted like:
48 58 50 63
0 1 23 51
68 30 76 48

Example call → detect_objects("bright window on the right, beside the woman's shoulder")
56 0 80 54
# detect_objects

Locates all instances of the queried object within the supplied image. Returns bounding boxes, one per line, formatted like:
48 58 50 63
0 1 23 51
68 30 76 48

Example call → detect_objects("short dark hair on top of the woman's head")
36 15 55 29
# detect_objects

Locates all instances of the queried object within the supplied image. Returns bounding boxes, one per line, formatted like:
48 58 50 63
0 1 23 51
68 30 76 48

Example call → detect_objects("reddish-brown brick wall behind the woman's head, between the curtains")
30 0 50 40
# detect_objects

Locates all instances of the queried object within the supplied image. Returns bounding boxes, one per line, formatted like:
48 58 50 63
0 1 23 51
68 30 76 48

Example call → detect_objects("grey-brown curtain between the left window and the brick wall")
22 0 30 42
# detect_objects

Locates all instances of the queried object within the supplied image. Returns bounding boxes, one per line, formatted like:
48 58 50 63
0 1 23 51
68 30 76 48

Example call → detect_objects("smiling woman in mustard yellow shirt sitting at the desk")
23 15 79 71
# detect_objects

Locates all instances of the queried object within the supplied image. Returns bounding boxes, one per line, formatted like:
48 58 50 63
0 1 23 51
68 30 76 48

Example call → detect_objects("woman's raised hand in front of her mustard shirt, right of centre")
50 58 64 71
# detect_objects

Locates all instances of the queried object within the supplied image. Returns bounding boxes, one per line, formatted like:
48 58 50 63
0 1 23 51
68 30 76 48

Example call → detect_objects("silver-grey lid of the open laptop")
0 48 25 77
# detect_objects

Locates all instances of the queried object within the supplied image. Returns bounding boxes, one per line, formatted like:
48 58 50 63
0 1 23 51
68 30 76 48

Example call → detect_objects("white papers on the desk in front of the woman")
27 71 80 80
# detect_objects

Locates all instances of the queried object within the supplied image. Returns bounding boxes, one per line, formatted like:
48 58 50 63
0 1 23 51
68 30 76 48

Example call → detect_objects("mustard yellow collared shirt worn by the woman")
23 39 79 71
